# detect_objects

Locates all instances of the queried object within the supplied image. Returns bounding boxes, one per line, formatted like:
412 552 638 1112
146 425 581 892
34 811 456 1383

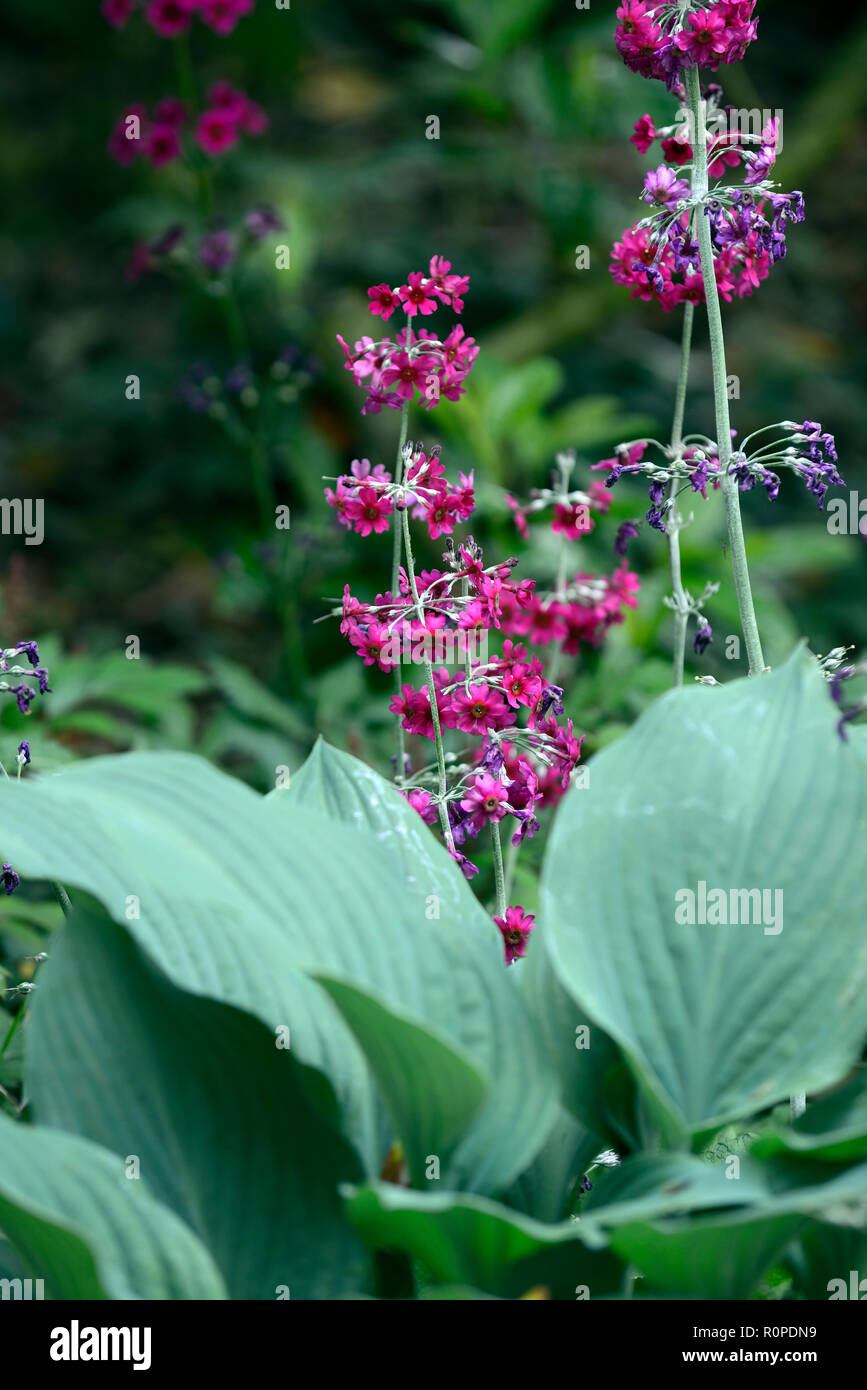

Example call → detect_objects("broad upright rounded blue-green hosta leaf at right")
542 652 867 1131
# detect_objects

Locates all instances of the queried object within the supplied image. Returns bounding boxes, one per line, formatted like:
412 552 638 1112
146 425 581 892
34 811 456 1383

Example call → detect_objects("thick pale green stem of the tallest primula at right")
686 67 764 676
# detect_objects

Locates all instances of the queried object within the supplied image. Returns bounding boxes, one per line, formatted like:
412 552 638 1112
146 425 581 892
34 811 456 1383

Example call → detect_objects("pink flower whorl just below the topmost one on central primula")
325 449 475 541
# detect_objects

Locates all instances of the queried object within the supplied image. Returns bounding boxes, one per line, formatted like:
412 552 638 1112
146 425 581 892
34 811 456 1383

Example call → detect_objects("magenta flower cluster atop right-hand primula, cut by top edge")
614 0 759 88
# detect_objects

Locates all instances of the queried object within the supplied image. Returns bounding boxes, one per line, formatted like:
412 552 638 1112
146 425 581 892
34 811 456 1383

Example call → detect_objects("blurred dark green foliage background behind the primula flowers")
0 0 867 787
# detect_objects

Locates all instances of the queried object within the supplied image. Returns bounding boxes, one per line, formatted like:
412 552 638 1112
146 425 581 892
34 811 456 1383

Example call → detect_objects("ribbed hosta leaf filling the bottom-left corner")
0 1115 226 1300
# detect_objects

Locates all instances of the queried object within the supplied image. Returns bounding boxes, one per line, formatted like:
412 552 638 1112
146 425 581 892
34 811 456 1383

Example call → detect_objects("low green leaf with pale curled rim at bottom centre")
345 1183 622 1298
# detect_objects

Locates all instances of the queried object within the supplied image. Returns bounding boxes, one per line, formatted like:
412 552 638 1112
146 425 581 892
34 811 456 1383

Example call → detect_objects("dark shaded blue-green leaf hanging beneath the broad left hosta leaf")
29 909 365 1298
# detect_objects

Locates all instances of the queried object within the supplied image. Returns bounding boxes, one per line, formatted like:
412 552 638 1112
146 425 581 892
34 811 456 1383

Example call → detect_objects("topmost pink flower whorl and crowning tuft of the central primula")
338 256 478 414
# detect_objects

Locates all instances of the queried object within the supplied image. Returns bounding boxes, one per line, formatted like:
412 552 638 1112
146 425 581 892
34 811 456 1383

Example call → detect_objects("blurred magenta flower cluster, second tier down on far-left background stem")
107 82 268 168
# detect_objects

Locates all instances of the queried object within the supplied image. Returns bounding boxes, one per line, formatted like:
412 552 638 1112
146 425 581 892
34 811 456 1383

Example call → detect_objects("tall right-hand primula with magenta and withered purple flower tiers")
605 0 843 685
